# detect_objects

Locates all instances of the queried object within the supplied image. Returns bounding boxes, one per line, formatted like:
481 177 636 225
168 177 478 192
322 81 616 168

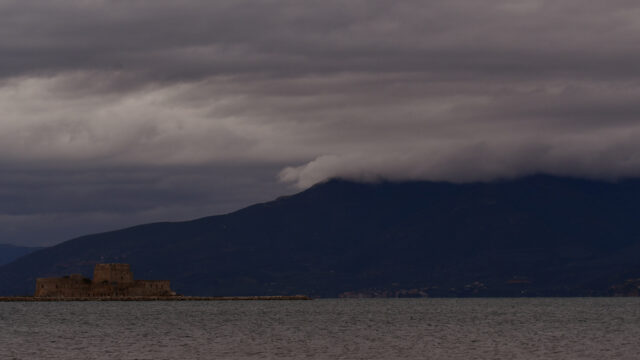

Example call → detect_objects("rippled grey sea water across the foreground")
0 298 640 359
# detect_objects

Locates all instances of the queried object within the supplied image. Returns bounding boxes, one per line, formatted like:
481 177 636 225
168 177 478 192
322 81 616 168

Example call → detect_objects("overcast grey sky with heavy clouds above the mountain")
0 0 640 245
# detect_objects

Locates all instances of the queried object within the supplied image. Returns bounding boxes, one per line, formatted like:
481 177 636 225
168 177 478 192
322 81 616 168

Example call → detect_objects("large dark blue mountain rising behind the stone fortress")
0 175 640 297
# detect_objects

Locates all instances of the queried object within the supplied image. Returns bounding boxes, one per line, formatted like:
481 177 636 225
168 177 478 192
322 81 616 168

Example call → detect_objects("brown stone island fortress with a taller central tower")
35 264 176 298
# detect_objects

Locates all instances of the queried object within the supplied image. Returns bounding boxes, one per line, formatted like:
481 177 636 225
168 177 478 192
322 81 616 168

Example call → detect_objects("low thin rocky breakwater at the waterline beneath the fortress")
0 295 311 302
